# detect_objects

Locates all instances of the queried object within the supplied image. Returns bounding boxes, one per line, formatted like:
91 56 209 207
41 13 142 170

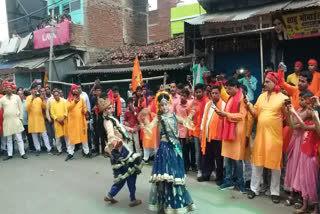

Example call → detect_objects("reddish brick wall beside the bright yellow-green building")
148 0 178 41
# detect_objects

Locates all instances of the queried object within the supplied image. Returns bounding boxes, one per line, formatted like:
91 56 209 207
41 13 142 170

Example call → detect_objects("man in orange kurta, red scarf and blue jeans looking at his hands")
216 78 248 193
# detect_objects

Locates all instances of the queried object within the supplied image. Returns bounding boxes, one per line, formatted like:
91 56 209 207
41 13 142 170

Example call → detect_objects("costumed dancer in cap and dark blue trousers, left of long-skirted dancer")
98 99 143 207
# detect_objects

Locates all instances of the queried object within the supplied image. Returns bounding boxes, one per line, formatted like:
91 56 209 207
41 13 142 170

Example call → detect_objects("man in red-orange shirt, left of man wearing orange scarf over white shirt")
190 83 210 177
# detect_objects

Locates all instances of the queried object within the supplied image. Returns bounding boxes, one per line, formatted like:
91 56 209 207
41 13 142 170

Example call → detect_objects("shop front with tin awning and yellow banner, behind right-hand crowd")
185 0 320 100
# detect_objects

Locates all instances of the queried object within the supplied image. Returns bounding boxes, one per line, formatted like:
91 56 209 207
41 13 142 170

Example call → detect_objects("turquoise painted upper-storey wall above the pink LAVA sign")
48 0 86 24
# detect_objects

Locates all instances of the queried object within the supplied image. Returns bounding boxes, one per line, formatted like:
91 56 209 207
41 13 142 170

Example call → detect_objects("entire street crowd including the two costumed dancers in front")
0 59 320 214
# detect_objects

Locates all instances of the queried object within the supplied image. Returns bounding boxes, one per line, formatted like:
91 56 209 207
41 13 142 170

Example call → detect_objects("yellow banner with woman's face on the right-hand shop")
273 9 320 40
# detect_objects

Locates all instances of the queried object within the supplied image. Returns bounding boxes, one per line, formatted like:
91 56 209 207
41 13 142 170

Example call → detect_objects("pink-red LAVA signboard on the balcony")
33 21 70 49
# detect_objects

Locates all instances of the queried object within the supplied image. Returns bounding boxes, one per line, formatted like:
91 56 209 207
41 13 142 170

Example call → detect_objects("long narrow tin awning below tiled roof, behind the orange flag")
68 63 191 75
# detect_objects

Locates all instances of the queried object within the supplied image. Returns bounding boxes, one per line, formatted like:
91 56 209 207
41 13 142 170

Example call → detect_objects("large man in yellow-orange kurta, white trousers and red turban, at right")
248 72 288 203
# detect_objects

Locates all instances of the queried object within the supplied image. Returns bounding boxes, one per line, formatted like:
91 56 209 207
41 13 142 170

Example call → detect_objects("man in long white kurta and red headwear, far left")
0 83 27 160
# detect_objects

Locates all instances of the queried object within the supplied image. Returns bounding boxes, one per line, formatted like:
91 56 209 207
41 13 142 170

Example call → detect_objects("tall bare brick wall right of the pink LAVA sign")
71 0 148 63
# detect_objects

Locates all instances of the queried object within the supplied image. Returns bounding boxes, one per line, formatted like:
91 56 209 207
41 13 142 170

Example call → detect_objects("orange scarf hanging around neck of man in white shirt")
201 99 222 155
